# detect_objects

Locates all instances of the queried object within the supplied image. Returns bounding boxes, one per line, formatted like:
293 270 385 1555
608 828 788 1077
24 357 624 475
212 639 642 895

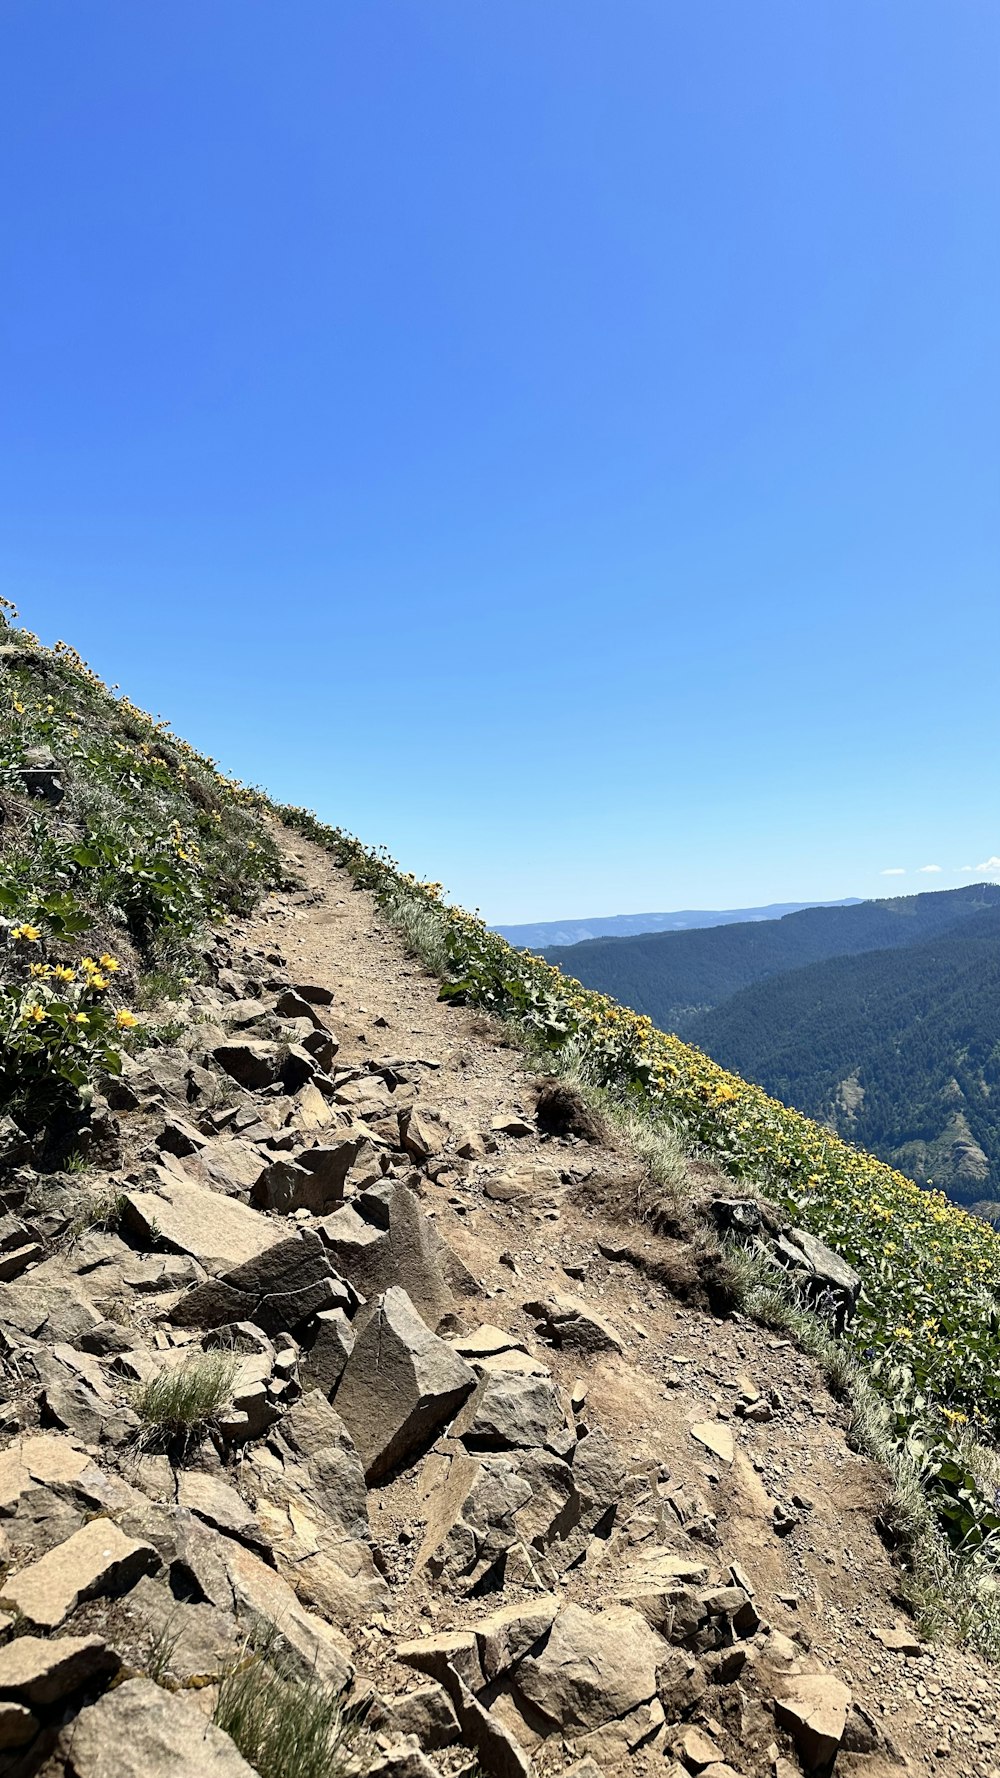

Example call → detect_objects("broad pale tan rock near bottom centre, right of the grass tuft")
514 1606 667 1734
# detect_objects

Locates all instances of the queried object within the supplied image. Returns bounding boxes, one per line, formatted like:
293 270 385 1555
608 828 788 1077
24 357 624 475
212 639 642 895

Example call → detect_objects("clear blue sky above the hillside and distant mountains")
0 0 1000 921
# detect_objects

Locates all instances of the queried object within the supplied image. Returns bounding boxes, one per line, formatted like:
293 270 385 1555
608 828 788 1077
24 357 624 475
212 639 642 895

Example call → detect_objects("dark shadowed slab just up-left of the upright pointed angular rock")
171 1211 346 1334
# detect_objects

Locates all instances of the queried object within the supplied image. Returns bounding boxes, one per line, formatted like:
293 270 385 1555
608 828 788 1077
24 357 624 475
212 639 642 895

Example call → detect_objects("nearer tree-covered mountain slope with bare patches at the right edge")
692 909 1000 1204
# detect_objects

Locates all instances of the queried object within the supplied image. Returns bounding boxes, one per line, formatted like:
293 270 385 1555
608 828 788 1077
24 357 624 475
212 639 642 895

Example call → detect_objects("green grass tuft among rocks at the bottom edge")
214 1645 365 1778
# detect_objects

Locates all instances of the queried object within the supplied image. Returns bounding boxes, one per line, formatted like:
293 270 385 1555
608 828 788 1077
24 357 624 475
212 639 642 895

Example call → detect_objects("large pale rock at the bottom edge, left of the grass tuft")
62 1678 254 1778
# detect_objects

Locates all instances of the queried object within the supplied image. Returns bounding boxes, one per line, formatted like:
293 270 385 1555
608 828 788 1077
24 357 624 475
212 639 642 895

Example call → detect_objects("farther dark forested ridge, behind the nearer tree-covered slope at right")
544 884 1000 1037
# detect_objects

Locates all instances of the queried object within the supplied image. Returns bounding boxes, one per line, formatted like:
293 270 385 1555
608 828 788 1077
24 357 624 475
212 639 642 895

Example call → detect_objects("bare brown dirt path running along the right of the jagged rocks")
236 841 1000 1778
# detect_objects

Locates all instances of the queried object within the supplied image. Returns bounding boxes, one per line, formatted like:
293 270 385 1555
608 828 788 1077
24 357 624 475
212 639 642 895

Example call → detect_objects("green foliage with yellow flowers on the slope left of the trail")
0 601 281 1131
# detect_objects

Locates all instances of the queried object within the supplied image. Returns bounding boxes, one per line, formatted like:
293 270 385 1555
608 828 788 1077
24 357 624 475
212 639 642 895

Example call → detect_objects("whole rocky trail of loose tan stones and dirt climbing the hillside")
0 836 1000 1778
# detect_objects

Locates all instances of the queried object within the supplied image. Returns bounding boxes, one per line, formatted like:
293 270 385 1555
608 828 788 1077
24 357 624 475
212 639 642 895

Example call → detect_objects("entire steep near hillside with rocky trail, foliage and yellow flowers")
0 604 1000 1778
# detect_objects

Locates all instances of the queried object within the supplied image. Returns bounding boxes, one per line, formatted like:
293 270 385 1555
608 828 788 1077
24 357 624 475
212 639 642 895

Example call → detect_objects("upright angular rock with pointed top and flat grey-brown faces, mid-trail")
336 1287 475 1481
